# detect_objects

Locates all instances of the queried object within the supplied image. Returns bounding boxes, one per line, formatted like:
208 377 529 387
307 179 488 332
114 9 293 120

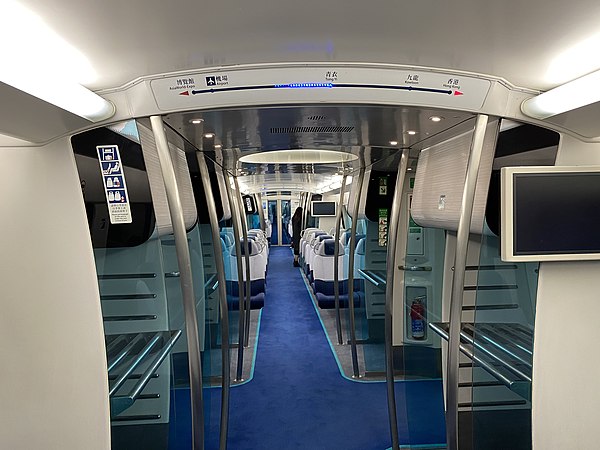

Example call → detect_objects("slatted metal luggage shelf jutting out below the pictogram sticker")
106 330 182 417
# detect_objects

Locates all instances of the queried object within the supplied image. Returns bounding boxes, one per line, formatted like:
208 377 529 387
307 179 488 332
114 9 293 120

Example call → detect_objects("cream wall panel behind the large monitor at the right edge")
532 136 600 450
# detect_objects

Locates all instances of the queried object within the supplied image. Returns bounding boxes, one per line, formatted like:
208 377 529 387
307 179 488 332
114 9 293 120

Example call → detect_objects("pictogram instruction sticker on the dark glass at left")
96 145 132 223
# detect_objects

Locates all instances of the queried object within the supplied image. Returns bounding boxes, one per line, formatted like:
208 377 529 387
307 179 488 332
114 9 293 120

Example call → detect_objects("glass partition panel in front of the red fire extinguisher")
394 201 446 448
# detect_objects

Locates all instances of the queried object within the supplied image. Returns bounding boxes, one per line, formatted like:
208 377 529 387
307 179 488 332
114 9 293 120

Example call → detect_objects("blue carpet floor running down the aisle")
169 247 445 450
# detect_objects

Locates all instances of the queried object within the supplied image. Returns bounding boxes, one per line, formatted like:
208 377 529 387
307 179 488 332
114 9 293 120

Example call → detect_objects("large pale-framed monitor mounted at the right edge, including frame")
501 166 600 261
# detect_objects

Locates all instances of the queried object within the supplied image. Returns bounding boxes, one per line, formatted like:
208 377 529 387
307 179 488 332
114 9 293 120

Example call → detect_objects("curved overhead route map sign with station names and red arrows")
150 66 491 111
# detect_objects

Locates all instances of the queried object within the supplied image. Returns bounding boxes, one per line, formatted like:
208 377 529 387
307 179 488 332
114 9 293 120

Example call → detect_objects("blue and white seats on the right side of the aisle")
299 228 365 309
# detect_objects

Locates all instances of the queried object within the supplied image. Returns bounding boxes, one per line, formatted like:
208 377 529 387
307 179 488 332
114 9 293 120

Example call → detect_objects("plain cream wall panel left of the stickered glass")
0 140 110 450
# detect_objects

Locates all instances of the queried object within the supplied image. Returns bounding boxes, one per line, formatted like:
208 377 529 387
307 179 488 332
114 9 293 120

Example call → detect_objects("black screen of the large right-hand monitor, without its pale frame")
513 172 600 256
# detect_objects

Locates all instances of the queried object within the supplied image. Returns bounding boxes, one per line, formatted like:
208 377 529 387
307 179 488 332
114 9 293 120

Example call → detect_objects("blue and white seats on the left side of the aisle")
221 229 269 310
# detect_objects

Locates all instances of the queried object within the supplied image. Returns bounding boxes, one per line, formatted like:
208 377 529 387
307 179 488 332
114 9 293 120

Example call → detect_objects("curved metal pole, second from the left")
198 152 230 450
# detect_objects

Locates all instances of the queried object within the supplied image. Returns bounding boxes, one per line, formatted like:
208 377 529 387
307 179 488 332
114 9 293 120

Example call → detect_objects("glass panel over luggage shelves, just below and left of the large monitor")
472 229 538 450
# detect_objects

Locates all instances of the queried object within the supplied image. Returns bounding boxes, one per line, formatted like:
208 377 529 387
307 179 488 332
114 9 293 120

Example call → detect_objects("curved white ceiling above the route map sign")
21 0 600 90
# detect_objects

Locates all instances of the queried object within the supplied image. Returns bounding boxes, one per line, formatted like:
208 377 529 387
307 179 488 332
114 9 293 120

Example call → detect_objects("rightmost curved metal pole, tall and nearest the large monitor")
446 114 488 450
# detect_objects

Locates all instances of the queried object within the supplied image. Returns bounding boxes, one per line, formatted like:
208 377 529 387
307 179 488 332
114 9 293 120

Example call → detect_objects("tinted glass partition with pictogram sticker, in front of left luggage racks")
72 122 203 450
